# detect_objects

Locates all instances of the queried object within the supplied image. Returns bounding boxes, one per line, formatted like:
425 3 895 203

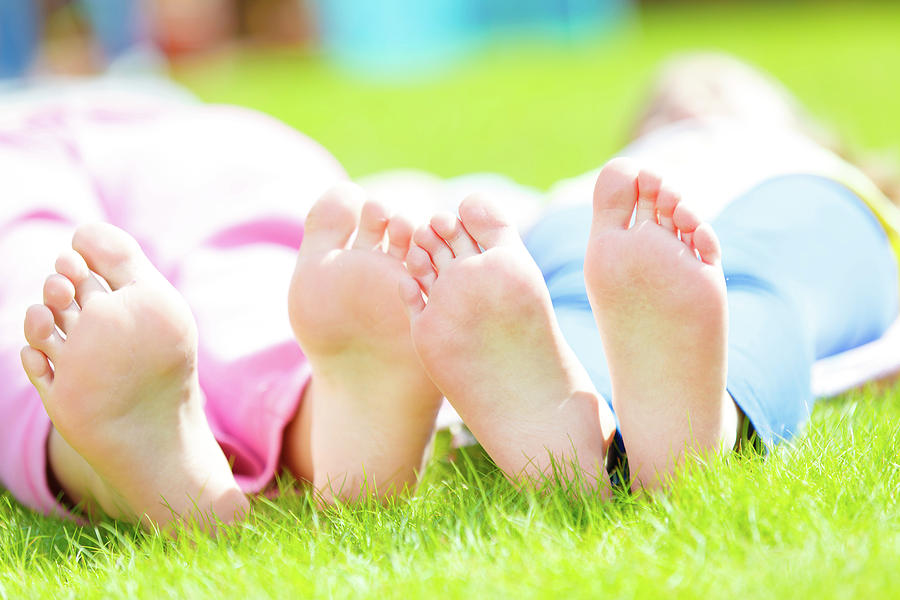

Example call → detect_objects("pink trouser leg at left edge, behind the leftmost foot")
0 143 121 515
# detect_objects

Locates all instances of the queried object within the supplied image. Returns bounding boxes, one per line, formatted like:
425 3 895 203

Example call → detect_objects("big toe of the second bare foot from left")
300 183 366 253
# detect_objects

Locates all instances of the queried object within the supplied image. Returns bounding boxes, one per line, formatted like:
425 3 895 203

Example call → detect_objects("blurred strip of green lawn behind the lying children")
173 2 900 188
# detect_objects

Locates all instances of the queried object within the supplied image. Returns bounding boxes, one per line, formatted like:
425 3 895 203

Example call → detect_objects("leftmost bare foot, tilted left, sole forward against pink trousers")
22 224 248 526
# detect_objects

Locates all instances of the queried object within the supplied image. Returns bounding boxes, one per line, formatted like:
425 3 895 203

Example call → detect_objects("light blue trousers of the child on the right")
525 175 900 446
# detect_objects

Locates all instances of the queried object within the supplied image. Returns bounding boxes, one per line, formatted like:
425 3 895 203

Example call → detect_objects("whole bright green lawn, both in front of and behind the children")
0 4 900 598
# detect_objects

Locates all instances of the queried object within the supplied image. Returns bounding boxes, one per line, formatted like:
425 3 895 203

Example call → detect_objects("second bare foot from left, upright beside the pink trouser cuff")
285 184 441 501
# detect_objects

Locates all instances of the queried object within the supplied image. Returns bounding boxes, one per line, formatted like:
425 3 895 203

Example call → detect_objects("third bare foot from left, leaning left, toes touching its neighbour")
401 197 615 490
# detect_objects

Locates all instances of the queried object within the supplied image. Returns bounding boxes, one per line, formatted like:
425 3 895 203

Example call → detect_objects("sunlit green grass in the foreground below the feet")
0 387 900 598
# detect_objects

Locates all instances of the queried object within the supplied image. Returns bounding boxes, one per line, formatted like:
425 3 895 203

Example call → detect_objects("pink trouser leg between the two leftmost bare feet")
64 104 345 502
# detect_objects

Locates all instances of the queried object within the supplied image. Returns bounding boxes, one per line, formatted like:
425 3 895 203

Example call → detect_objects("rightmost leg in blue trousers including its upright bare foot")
585 161 897 486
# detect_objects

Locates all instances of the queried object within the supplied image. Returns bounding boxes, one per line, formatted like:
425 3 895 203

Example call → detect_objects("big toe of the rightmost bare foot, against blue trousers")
591 158 639 234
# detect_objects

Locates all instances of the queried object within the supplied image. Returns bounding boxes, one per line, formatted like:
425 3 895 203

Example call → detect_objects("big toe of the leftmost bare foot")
72 223 156 290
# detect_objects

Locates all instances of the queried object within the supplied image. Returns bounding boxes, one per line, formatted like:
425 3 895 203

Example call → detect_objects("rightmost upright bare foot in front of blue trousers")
584 159 738 487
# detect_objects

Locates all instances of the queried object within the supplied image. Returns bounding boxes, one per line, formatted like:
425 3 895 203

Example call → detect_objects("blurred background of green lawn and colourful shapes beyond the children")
0 0 900 188
